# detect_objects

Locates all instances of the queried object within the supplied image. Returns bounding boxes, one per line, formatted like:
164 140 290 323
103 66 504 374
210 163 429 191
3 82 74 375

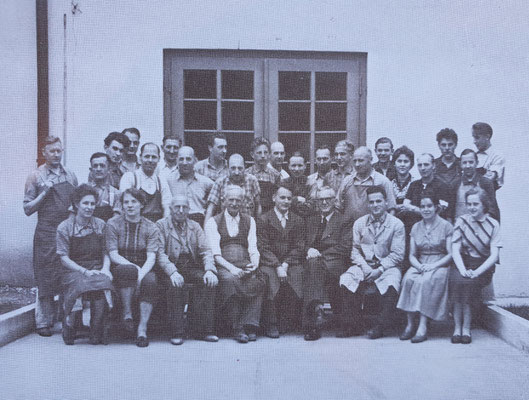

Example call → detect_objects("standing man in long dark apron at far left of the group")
24 136 77 336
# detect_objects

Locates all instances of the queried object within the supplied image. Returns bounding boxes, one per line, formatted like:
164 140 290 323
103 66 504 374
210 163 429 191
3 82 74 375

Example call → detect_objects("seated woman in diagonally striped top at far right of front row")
450 188 502 344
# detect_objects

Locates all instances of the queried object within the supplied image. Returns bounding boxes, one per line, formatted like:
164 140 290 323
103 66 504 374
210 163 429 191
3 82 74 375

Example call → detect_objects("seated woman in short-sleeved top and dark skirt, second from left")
106 188 159 347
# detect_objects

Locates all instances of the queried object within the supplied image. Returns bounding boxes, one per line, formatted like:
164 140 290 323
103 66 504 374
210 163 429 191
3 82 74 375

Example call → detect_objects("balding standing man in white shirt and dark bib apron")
119 143 171 222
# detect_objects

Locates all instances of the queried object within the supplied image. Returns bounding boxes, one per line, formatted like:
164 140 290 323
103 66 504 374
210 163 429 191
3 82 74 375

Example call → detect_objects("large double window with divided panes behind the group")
164 49 367 170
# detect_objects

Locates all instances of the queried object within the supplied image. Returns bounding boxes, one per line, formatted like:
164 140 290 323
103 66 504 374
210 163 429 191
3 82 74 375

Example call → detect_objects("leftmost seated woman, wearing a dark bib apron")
57 185 113 345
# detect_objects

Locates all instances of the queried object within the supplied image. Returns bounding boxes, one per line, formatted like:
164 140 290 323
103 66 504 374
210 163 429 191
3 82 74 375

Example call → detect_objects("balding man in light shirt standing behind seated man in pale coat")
336 147 397 226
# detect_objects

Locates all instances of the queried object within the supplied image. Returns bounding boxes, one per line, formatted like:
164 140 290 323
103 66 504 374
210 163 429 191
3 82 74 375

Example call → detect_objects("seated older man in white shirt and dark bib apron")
205 185 266 343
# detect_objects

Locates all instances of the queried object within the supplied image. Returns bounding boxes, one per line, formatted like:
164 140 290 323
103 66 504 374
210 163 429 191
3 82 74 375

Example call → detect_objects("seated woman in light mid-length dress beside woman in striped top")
397 192 453 343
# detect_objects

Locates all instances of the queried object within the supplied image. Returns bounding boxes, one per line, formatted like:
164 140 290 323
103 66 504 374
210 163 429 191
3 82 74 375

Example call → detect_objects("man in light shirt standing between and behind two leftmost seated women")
89 153 121 222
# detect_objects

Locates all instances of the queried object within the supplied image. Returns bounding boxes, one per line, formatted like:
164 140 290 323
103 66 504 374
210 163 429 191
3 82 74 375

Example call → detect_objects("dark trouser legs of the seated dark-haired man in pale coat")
341 282 399 329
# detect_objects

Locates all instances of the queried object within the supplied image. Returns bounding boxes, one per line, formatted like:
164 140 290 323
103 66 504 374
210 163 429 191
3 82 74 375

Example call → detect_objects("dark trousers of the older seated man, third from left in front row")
165 268 217 337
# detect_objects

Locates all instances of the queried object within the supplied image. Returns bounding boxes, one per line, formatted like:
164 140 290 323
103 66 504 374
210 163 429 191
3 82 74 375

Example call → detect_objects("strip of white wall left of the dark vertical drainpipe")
0 0 37 284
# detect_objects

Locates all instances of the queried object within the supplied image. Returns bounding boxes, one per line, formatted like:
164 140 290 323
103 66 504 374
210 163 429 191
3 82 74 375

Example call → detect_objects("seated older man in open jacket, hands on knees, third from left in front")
157 194 219 345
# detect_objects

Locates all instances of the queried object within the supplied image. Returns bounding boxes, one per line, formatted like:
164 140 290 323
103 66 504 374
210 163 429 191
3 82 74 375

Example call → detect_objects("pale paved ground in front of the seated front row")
0 324 529 400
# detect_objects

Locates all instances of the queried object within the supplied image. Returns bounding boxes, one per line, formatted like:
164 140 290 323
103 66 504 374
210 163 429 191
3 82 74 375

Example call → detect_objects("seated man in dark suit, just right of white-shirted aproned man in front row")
257 186 304 339
